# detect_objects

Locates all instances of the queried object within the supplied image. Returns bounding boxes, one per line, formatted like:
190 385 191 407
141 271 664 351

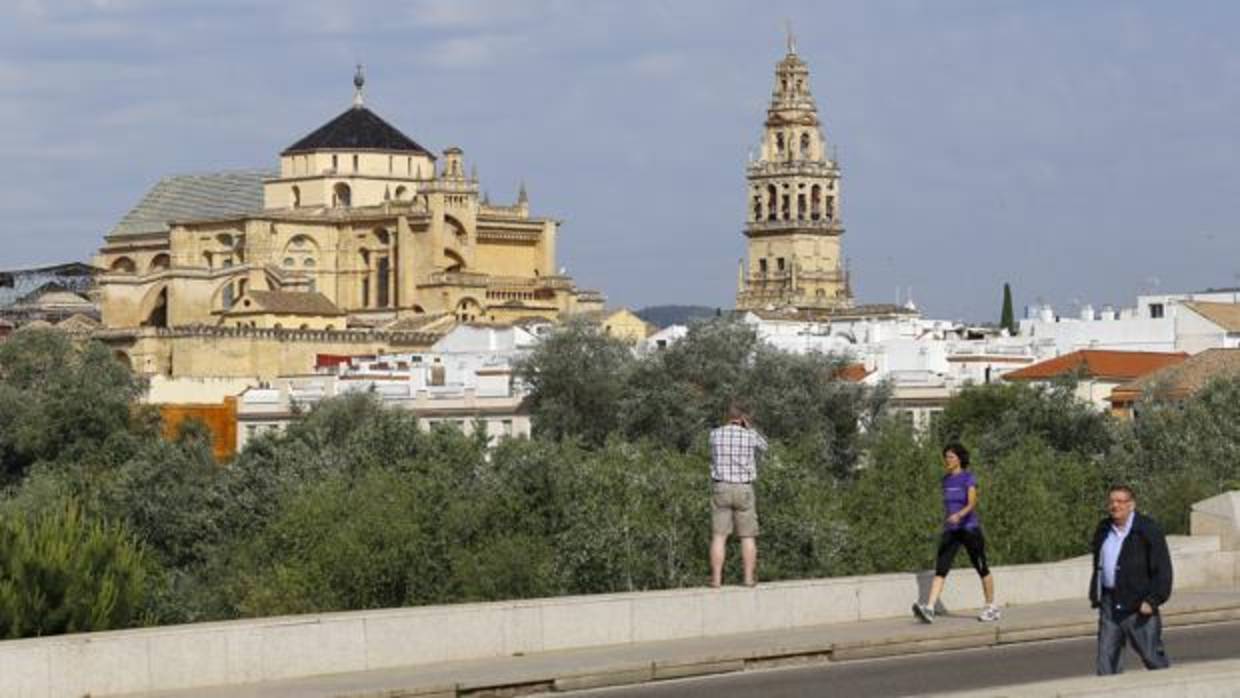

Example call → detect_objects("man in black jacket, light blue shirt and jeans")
1089 485 1172 674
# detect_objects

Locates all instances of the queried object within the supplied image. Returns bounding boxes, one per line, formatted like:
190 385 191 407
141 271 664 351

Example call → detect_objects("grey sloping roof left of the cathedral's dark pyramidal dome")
108 170 275 237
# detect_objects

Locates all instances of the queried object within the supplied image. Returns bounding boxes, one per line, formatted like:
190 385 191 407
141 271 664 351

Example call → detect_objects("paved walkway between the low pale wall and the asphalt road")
116 589 1240 698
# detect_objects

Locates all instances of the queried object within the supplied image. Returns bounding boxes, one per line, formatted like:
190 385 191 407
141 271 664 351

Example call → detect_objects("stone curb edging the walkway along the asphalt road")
336 605 1240 698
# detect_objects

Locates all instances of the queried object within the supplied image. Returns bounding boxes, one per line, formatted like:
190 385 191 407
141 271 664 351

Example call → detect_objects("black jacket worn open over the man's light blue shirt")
1089 512 1172 611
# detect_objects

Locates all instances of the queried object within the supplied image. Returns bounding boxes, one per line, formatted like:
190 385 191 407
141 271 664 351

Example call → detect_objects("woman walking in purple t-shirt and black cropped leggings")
913 444 999 622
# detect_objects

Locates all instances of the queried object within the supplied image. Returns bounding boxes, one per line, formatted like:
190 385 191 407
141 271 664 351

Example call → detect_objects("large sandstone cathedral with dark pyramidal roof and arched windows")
94 68 603 376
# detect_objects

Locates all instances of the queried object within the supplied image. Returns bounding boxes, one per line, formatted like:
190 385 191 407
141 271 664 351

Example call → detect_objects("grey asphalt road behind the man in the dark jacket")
574 622 1240 698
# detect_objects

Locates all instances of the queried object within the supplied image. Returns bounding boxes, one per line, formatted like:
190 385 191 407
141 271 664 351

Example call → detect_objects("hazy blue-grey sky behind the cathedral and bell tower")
0 0 1240 321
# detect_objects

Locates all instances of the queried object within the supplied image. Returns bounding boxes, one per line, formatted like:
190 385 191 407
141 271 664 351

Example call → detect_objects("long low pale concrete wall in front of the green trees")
0 537 1240 698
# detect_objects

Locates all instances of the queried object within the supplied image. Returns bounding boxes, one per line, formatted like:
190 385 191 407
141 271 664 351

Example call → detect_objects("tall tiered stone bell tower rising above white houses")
737 31 853 310
